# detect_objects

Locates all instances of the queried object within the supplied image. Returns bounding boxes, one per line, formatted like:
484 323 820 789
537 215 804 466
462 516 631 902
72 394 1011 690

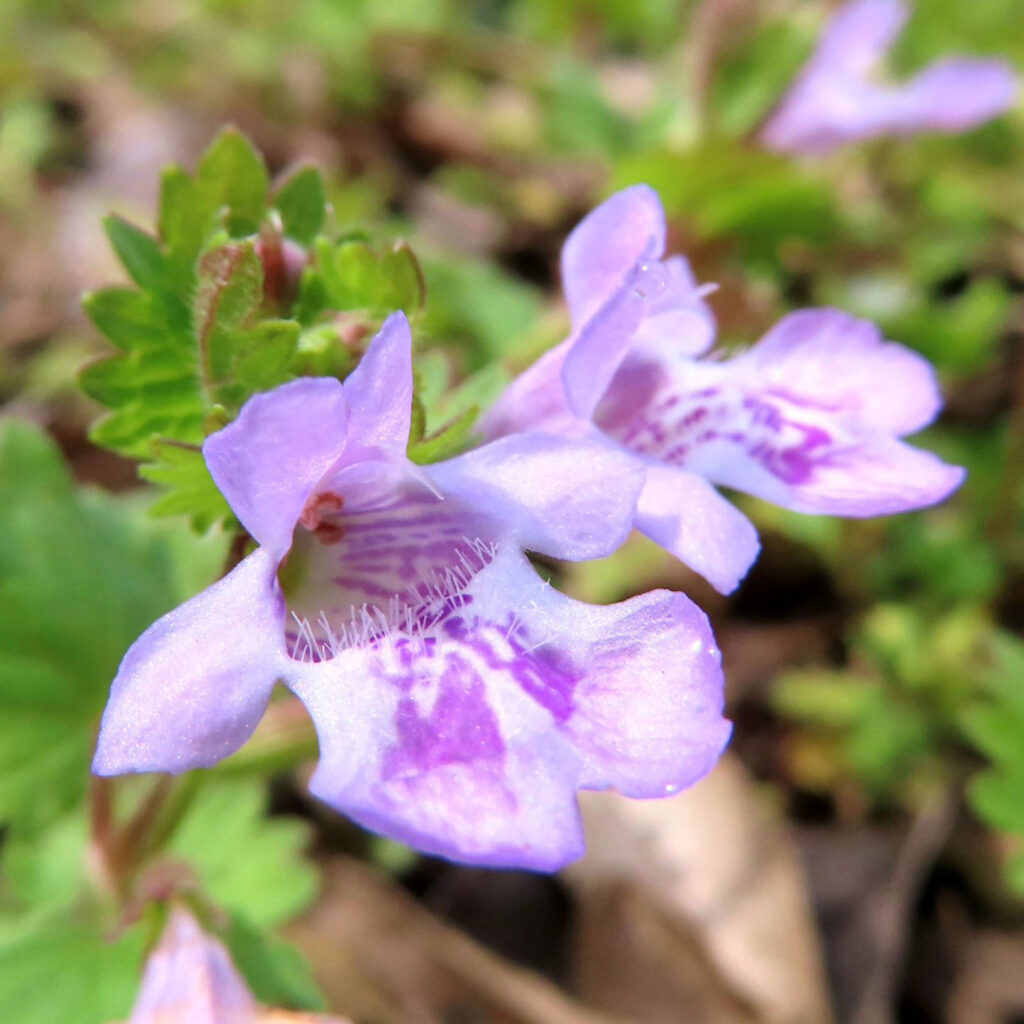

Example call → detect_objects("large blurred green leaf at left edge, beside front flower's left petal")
0 421 201 831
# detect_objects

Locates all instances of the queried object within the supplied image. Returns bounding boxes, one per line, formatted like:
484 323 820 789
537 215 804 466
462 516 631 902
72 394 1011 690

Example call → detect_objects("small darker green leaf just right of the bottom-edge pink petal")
220 913 327 1011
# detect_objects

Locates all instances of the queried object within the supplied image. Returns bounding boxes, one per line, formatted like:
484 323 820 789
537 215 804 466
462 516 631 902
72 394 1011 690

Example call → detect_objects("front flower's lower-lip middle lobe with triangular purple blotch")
289 642 583 870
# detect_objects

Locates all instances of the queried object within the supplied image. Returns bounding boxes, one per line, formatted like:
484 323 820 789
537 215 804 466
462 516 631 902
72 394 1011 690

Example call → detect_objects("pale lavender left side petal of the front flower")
92 549 286 775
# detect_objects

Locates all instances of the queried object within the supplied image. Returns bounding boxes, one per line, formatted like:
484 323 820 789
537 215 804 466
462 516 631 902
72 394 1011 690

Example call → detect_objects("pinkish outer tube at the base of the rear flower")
477 338 575 440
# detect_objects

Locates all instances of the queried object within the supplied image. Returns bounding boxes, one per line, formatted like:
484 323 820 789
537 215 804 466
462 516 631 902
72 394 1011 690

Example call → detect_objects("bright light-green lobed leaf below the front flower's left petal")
169 776 317 928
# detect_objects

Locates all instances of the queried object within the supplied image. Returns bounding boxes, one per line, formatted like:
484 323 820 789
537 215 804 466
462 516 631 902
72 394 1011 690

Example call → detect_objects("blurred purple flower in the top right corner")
761 0 1017 154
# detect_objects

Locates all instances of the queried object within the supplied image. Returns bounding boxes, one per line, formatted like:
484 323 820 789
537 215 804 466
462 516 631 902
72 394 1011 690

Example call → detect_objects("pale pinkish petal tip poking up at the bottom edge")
128 906 260 1024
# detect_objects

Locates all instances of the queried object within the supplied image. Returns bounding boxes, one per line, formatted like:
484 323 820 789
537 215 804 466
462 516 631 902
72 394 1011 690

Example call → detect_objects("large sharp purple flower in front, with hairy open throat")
93 314 729 869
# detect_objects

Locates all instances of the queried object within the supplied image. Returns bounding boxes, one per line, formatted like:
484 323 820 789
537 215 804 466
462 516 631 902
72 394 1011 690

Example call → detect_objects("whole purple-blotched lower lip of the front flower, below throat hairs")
289 549 728 870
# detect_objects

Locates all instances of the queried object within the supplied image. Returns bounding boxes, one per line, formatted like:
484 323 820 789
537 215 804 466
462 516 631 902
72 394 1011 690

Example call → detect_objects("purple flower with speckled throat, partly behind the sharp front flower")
483 185 964 592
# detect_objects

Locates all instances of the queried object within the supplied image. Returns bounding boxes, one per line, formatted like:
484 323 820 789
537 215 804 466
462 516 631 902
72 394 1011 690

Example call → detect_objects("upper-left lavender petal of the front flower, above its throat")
203 377 349 560
